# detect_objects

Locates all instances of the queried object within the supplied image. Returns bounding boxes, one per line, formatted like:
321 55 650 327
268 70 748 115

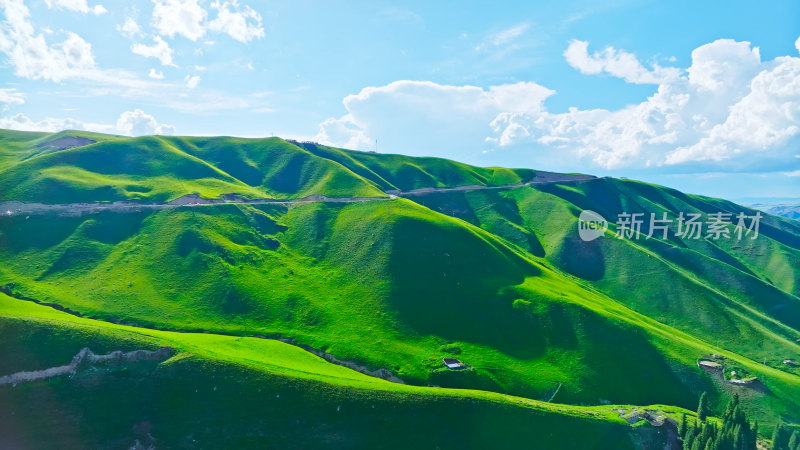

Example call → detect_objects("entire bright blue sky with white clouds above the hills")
0 0 800 198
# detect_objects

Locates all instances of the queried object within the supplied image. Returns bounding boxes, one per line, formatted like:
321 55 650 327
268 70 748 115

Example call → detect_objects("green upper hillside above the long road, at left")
0 130 534 203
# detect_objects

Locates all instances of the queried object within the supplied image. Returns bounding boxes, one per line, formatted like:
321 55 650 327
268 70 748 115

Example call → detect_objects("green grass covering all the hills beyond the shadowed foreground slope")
0 127 800 436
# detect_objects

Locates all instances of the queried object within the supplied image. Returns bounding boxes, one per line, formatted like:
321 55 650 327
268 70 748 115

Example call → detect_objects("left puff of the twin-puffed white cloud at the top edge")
153 0 208 41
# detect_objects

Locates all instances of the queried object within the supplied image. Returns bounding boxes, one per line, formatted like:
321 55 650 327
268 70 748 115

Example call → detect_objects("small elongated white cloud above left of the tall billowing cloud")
564 40 681 84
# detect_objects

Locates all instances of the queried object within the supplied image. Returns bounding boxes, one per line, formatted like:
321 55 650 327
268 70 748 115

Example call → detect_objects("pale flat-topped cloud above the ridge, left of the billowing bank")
316 80 553 156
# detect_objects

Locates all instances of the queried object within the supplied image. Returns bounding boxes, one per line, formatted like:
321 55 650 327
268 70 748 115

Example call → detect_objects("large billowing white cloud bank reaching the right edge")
491 39 800 171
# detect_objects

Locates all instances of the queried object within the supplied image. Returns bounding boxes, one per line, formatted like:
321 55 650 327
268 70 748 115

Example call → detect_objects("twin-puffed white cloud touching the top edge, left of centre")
153 0 264 42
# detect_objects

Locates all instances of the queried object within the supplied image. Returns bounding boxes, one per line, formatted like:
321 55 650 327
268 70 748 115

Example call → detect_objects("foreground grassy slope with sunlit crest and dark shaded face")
0 293 668 449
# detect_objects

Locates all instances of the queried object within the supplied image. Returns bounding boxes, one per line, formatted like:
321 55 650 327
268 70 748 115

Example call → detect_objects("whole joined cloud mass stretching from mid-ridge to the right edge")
317 35 800 172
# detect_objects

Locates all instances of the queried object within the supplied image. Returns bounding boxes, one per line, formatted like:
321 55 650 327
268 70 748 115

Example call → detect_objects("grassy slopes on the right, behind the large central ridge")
410 179 800 371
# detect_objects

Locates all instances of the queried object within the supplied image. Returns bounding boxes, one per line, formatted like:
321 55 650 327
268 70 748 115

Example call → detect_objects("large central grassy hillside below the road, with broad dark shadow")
0 199 800 428
